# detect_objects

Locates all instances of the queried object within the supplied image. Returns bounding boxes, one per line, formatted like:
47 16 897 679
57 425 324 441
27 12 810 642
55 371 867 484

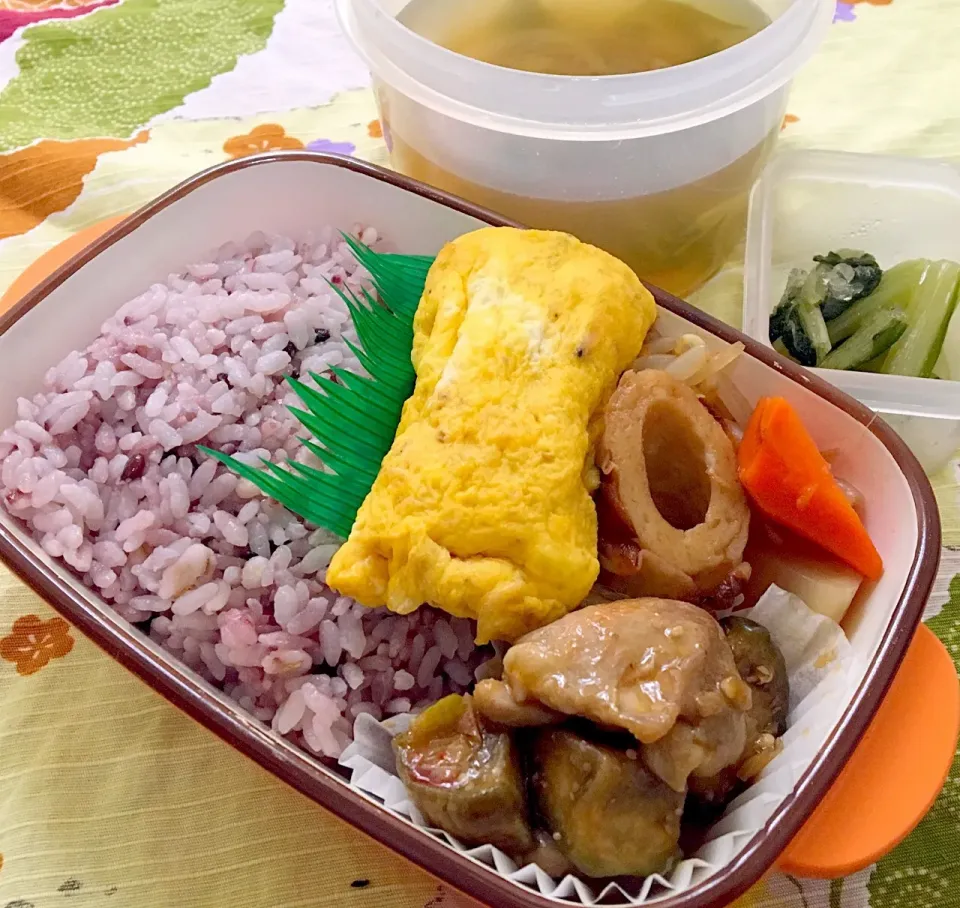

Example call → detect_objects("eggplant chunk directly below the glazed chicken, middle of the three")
533 728 685 878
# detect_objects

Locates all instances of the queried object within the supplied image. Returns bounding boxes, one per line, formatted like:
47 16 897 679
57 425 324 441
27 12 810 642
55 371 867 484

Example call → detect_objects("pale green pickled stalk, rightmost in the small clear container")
883 261 960 378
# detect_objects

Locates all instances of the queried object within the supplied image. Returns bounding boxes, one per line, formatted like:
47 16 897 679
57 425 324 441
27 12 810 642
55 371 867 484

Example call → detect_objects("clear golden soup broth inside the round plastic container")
386 0 779 296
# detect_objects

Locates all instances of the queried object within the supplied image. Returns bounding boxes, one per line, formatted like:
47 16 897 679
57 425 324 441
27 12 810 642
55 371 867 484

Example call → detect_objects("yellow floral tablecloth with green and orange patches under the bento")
0 0 960 908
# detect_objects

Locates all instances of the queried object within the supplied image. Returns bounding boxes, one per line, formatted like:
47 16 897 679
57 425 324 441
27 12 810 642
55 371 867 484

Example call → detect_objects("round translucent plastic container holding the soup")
337 0 835 296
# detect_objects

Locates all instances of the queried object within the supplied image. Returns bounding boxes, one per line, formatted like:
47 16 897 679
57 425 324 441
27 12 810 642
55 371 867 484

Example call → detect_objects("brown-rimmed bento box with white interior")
0 152 940 908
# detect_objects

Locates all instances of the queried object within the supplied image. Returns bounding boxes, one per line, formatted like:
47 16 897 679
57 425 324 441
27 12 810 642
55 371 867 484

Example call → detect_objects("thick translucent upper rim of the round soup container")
337 0 834 140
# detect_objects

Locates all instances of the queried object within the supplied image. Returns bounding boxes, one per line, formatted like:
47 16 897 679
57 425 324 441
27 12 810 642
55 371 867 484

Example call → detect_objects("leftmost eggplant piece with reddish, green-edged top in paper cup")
393 695 537 862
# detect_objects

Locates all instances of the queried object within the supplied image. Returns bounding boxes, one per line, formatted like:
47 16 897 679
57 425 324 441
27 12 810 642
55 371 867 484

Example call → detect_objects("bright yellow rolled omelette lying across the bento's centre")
326 228 656 642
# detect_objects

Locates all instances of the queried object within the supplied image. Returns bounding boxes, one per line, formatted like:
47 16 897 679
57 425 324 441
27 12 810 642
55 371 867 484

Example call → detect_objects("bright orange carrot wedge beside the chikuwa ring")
737 397 883 580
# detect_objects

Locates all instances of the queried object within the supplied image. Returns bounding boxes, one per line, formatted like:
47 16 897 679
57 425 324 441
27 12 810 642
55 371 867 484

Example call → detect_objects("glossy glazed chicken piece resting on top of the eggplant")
492 599 751 791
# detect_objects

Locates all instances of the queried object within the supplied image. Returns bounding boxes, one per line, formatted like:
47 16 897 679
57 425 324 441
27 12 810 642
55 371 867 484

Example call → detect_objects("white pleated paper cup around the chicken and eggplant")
340 587 858 905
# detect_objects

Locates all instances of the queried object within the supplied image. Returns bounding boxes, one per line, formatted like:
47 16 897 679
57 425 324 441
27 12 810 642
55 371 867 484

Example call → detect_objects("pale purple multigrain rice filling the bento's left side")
0 227 488 757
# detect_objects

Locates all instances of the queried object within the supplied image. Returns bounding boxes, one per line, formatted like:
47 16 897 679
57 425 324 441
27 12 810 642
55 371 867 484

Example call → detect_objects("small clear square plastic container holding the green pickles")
743 151 960 472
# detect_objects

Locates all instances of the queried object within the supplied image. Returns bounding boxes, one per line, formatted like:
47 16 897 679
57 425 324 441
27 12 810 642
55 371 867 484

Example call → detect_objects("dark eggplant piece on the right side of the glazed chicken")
690 615 790 804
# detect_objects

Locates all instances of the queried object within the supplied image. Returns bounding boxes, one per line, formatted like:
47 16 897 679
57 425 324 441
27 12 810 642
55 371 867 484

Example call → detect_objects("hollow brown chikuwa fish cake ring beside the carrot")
598 370 750 599
